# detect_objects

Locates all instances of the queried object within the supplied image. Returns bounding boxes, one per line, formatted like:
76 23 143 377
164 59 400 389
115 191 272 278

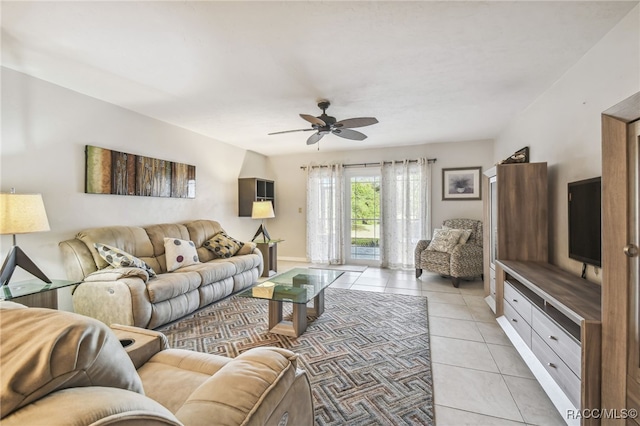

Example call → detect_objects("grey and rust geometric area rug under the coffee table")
158 288 435 425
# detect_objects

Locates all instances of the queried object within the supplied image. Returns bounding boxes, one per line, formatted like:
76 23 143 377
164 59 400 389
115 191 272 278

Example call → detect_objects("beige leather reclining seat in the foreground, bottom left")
0 302 313 426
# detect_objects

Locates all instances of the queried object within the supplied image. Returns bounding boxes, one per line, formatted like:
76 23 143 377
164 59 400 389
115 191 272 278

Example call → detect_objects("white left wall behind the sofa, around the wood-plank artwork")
0 68 266 310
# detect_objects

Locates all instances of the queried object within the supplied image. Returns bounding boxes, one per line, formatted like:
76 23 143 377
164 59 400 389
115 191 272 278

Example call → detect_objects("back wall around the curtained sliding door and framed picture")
268 139 493 260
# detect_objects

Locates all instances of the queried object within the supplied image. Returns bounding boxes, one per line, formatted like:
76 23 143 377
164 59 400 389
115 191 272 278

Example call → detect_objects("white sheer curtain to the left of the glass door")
307 164 344 264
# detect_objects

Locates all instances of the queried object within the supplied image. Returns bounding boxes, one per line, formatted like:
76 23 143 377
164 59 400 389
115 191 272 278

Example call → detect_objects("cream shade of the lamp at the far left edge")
0 193 51 234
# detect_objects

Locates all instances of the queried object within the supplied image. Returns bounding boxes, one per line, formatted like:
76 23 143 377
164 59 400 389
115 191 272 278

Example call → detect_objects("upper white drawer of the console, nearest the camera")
531 309 582 377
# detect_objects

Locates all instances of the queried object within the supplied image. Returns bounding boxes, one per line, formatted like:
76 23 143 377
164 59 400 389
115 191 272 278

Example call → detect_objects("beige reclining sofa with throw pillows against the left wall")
60 220 264 329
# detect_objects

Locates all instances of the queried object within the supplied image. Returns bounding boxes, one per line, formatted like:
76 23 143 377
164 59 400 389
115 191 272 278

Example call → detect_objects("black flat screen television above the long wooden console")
568 177 602 267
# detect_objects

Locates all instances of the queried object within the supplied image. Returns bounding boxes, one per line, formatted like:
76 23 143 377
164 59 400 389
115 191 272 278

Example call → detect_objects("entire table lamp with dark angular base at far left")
0 189 51 287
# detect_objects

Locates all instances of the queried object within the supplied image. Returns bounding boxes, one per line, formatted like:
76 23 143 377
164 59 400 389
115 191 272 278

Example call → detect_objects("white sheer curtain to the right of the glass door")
380 158 431 268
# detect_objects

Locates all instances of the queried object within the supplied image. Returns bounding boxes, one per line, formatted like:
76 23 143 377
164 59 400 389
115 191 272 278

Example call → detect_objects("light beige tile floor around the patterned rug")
278 261 566 426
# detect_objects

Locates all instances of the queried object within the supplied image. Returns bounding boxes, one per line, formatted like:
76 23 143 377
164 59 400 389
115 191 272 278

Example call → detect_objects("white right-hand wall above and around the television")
495 6 640 282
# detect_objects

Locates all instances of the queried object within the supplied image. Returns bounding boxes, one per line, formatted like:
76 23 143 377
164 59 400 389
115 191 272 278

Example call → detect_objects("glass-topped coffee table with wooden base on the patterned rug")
238 268 344 337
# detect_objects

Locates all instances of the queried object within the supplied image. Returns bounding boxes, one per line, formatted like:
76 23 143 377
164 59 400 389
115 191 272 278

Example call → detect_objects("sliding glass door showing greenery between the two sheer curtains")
344 168 381 266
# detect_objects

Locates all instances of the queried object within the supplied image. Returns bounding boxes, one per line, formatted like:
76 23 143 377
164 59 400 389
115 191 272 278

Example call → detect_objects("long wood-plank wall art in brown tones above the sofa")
85 145 196 198
